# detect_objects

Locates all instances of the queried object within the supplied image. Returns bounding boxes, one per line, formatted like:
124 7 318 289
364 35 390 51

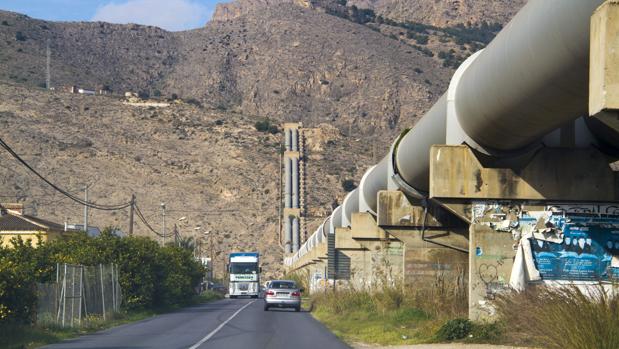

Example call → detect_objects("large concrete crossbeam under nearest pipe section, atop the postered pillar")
430 145 619 202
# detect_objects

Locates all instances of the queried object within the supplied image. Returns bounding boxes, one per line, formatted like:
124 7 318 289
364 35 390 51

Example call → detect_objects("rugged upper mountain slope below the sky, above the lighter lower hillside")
0 4 451 139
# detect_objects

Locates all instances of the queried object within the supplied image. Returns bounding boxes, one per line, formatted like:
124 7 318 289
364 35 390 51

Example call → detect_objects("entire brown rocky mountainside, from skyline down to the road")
0 0 524 273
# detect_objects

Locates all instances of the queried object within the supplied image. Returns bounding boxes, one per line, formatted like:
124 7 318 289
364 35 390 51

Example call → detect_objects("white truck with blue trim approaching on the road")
228 252 261 298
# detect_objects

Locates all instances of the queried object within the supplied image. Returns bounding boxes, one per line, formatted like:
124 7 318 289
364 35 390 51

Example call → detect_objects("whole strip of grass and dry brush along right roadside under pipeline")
312 286 619 349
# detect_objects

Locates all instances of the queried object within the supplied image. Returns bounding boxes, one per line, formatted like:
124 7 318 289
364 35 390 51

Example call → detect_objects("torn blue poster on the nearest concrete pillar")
531 217 619 281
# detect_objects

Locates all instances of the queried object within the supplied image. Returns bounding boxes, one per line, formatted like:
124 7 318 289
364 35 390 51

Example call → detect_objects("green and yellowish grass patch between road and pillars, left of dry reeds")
312 287 467 345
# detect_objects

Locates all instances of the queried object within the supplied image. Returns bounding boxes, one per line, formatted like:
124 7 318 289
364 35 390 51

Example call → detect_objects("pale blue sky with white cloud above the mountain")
0 0 224 31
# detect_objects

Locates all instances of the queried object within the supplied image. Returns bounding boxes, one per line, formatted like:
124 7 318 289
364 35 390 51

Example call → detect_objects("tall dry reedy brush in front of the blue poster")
495 286 619 349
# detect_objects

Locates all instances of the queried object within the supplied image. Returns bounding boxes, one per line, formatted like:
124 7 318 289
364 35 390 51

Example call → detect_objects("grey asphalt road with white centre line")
45 299 349 349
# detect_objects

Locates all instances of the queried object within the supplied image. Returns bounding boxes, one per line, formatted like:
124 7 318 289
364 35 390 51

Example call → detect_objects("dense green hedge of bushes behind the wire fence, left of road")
0 229 204 325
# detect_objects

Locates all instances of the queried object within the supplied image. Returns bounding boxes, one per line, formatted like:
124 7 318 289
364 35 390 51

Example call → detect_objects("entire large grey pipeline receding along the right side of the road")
286 0 613 266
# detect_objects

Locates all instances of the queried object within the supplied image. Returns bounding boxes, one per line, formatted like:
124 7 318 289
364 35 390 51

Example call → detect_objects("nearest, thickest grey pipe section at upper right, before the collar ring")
455 0 604 150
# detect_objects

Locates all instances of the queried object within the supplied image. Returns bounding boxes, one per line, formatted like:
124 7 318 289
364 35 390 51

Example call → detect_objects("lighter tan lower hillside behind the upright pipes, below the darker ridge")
0 83 373 275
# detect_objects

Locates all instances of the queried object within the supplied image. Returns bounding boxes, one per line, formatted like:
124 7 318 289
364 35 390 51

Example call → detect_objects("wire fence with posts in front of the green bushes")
37 264 122 327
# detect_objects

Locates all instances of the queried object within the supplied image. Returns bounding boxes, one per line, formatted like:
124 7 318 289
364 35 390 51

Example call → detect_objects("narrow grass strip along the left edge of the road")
0 291 223 349
